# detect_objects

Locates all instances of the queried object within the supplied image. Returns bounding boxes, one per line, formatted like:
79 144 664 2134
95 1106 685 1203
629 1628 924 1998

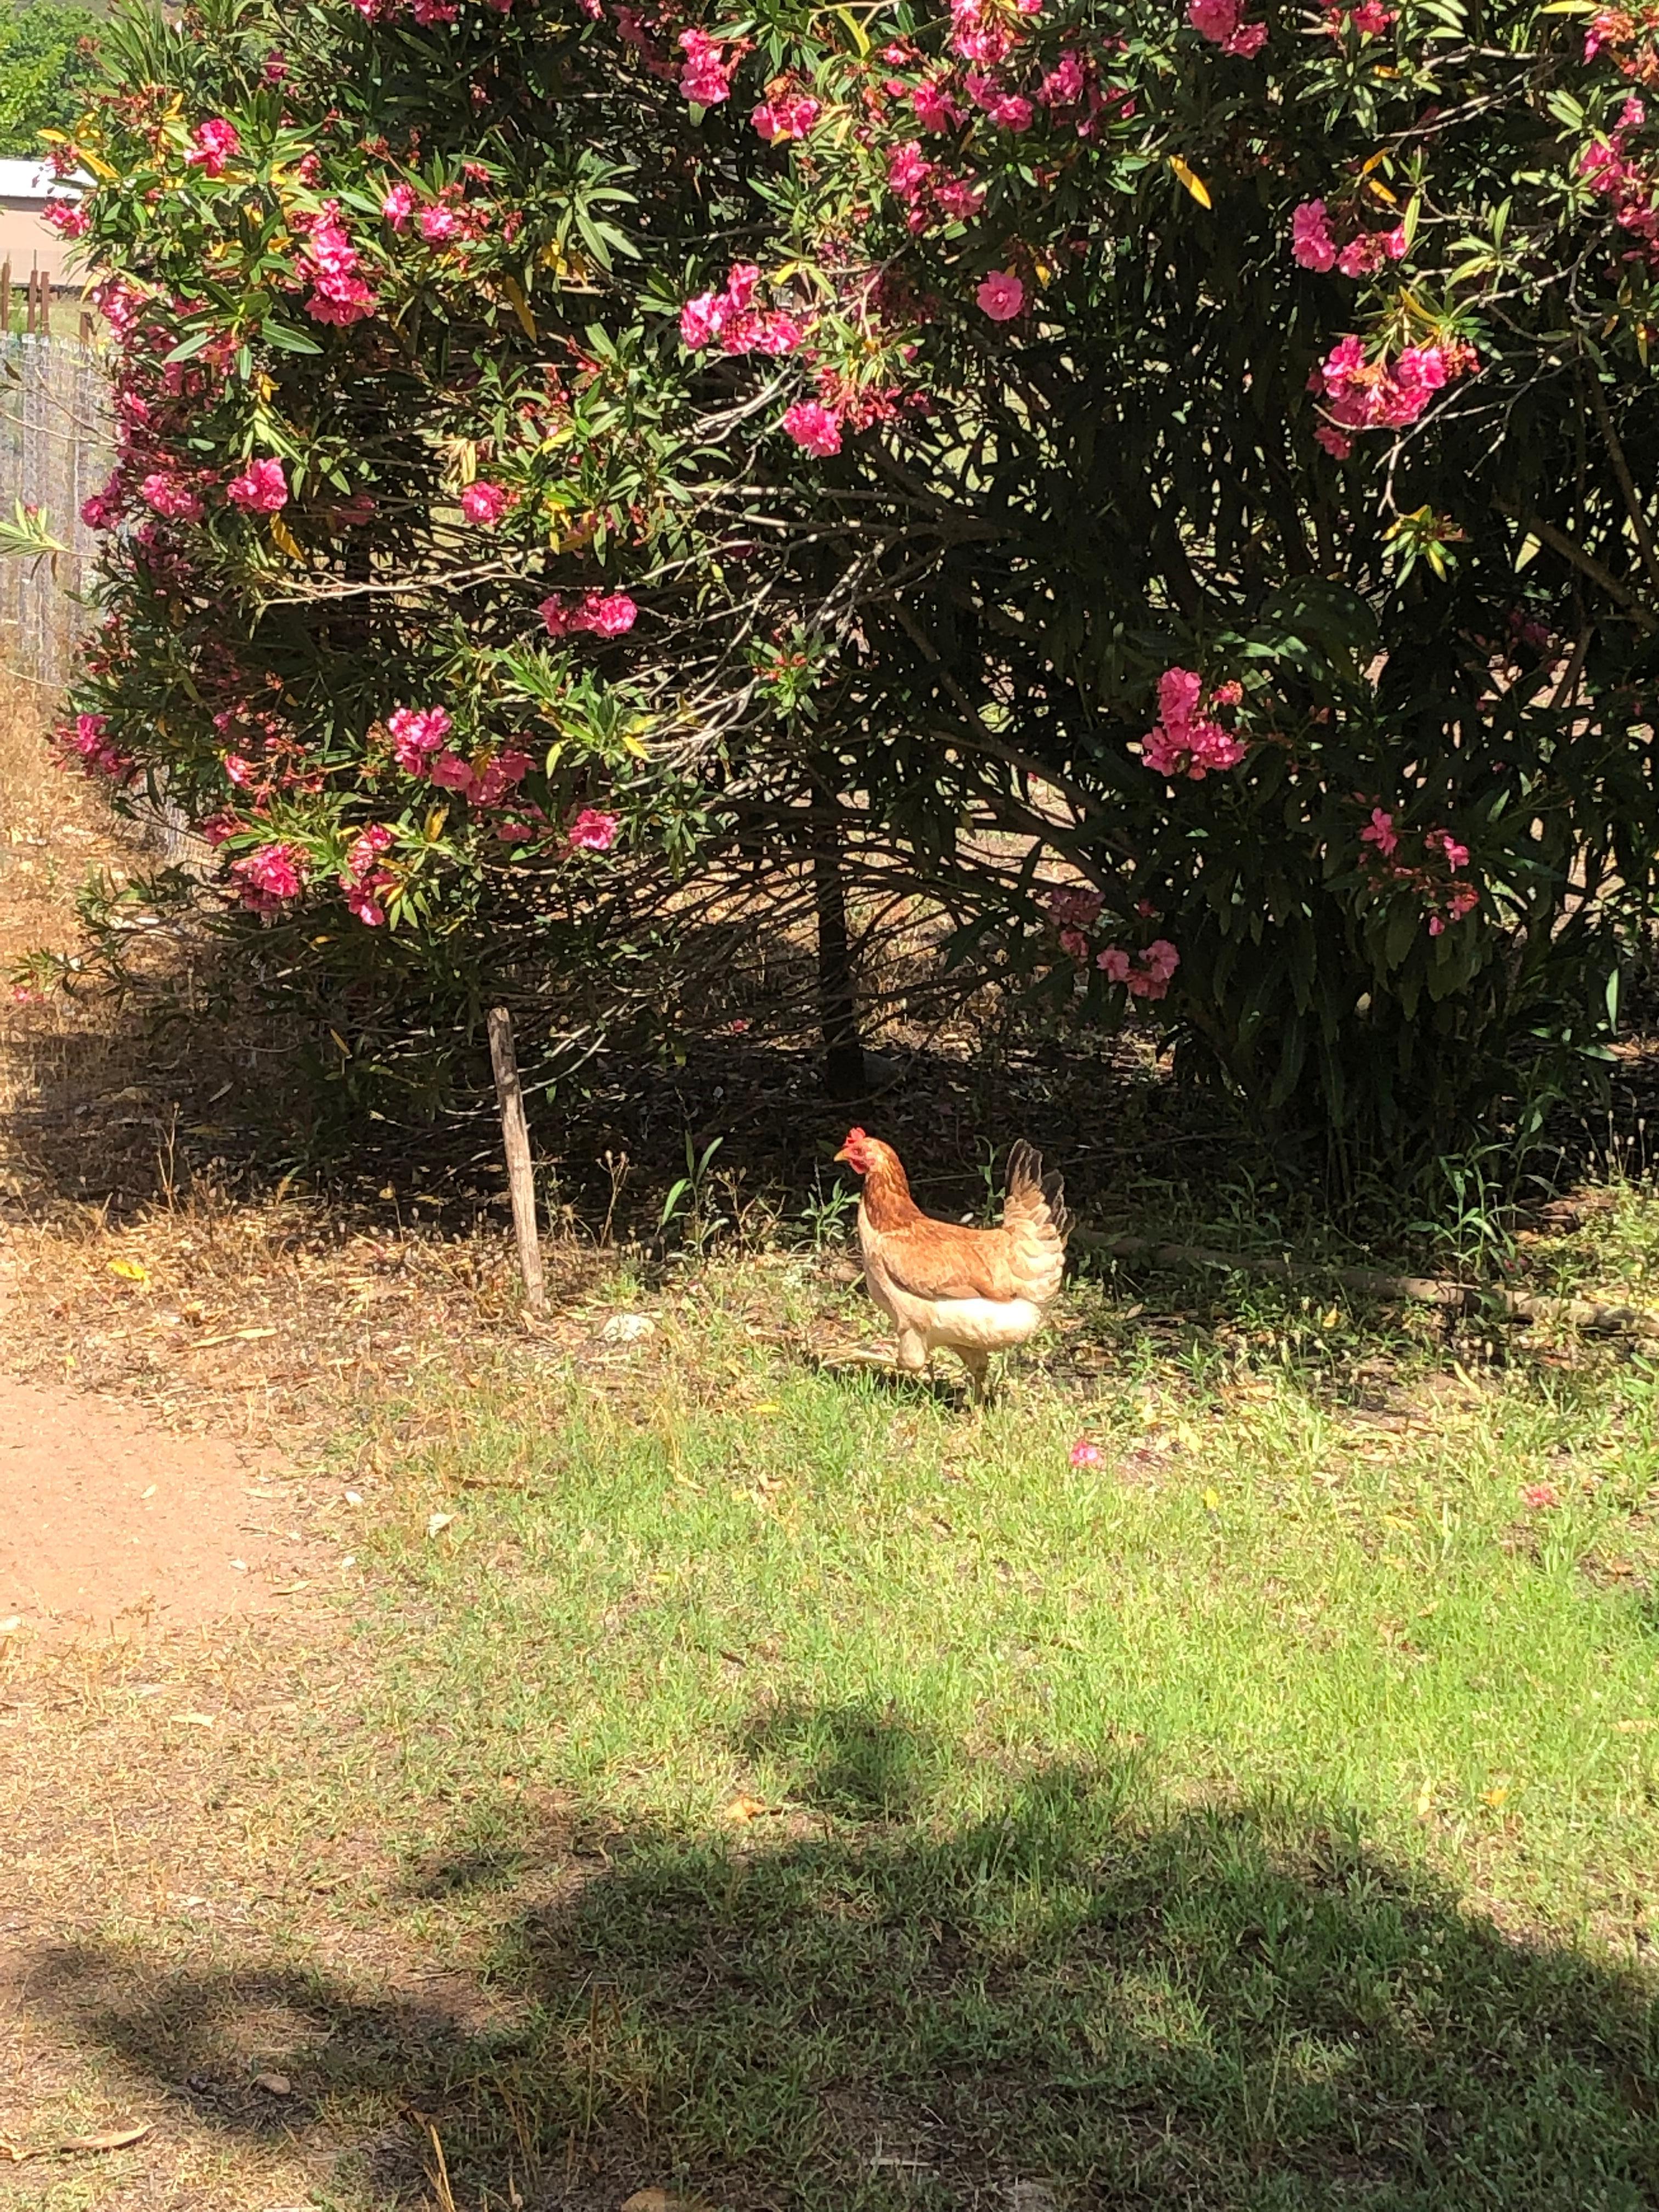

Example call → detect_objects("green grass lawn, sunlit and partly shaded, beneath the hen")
29 1248 1659 2212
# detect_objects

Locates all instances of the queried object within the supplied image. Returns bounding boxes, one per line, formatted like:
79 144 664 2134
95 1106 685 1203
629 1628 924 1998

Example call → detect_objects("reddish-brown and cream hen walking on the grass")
836 1128 1070 1398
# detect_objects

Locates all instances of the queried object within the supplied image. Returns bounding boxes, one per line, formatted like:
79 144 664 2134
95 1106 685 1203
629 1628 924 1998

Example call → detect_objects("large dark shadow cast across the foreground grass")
29 1708 1659 2212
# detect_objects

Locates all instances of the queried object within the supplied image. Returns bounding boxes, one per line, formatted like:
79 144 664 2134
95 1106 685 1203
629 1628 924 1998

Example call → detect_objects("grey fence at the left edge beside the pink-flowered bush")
0 332 115 690
